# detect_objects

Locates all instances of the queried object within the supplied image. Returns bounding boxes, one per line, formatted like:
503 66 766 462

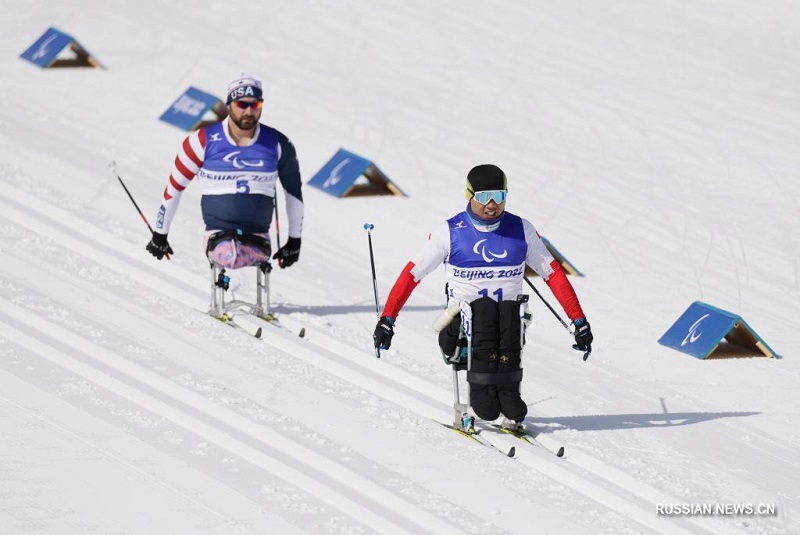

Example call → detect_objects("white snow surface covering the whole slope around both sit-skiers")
0 0 800 535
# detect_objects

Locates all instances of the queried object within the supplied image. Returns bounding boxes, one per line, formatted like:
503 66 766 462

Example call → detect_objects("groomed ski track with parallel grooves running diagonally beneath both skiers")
0 183 752 534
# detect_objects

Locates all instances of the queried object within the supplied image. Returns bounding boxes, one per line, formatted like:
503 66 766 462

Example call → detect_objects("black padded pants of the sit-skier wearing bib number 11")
439 297 528 421
